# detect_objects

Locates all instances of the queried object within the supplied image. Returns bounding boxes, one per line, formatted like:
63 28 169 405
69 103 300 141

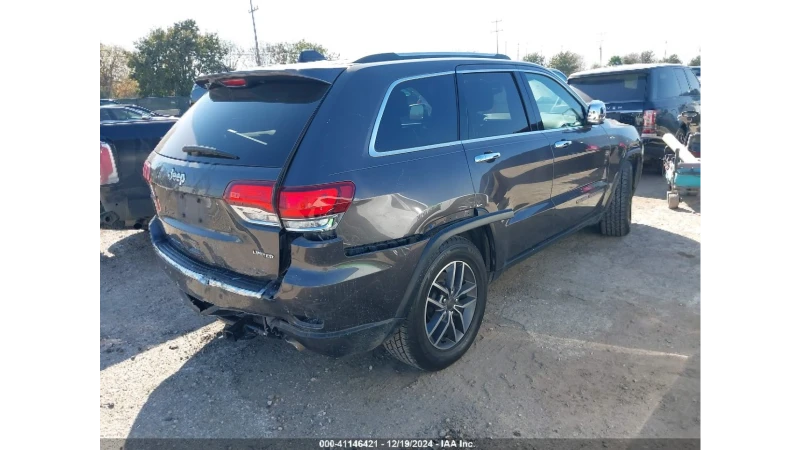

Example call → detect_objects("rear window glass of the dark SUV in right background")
569 73 647 103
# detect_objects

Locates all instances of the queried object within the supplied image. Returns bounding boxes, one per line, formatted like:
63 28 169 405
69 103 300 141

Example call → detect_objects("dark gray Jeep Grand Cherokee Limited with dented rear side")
144 53 642 370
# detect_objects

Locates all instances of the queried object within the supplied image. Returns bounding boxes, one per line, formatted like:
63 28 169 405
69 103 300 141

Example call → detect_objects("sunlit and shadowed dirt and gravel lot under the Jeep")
99 176 705 438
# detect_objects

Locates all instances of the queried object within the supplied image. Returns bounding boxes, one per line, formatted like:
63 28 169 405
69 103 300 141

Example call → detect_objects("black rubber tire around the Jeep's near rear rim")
383 237 488 371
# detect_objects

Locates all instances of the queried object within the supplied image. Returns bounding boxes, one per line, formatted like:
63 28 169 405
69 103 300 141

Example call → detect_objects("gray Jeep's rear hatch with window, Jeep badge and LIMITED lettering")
145 69 341 280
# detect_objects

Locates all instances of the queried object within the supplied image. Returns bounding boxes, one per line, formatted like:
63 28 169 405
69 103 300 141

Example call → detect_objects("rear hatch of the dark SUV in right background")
569 72 648 133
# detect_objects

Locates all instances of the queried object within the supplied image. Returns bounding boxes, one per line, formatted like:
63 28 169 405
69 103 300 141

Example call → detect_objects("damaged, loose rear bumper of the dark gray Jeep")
150 217 422 357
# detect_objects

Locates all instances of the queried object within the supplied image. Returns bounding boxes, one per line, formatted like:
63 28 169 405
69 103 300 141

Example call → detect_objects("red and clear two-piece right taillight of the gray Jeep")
224 181 356 231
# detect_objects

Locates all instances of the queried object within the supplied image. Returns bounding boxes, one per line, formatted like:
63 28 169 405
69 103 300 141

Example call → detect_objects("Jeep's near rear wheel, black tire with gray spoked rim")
384 237 488 371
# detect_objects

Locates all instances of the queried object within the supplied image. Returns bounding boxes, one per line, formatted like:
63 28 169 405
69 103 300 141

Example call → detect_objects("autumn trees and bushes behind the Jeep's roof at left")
97 20 339 98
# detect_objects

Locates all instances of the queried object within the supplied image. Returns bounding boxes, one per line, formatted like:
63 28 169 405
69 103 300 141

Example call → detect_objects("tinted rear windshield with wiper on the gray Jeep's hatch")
156 79 329 167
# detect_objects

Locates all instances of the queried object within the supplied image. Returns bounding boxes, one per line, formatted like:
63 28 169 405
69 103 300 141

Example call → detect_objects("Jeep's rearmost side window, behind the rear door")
373 75 458 153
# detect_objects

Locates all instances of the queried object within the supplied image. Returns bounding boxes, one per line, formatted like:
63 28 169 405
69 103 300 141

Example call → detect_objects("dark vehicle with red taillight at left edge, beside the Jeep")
97 115 178 229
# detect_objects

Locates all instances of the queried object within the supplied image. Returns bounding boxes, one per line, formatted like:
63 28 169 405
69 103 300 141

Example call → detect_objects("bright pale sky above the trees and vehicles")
96 0 705 66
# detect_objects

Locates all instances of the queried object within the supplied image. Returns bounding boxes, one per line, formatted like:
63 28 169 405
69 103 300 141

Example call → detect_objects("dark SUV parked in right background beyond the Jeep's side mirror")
568 64 702 167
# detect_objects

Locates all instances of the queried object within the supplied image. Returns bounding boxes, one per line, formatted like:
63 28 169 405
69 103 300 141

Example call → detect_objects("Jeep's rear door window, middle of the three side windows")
459 72 530 139
